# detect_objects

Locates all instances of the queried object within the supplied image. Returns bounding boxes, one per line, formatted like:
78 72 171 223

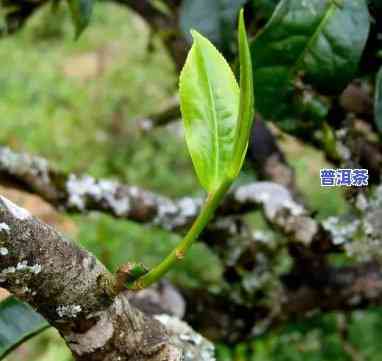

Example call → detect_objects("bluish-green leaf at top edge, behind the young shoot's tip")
180 0 246 53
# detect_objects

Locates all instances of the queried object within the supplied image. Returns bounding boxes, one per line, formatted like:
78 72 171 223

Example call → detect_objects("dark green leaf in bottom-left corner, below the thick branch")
0 297 49 359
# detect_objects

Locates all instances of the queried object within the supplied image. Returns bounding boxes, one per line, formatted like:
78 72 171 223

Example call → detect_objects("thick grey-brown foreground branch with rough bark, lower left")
0 197 214 361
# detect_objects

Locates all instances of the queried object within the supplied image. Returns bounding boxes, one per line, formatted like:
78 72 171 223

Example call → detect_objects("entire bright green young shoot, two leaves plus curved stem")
130 10 254 289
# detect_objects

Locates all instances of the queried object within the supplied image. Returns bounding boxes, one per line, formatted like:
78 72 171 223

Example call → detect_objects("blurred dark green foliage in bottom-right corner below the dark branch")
218 309 382 361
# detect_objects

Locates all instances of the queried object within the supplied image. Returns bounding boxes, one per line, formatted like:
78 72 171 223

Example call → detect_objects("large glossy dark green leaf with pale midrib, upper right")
251 0 369 118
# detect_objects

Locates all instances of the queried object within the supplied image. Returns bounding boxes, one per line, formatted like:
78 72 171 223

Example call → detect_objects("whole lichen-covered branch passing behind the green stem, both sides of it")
0 147 320 243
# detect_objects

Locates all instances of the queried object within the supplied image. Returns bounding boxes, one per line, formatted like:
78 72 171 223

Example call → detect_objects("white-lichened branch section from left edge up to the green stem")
0 147 201 229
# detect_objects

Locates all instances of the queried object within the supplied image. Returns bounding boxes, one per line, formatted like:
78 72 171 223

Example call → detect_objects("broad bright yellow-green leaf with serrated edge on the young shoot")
180 32 239 191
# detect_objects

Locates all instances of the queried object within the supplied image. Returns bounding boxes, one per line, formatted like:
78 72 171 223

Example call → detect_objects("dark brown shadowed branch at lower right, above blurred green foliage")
184 262 382 343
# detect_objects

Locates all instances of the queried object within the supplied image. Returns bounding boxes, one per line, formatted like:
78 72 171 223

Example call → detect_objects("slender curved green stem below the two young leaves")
129 181 232 290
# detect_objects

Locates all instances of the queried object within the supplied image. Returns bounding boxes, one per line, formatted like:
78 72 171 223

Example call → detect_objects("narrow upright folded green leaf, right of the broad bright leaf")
231 10 255 179
